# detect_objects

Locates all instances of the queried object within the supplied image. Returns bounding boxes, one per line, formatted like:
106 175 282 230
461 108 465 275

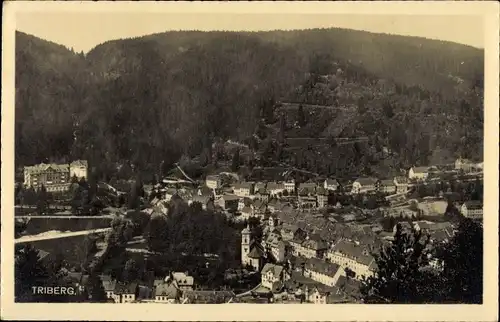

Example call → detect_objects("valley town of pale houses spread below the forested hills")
16 152 483 304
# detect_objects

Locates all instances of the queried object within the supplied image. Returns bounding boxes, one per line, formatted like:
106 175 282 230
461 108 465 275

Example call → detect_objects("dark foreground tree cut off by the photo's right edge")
438 218 484 304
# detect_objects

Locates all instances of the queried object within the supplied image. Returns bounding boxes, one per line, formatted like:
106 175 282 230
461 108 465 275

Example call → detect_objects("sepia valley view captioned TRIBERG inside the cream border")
2 3 498 320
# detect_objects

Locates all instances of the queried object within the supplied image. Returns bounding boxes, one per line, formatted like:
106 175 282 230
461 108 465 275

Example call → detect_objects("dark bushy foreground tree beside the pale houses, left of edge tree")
361 224 437 304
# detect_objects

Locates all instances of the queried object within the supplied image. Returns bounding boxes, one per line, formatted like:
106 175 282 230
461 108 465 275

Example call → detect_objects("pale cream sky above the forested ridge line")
16 11 484 53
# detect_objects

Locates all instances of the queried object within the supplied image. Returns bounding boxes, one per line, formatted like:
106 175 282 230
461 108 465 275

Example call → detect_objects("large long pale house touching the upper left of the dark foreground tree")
327 240 376 279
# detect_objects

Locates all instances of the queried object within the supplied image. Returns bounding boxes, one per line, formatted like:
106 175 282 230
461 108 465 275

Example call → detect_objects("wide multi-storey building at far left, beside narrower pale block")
24 163 71 192
